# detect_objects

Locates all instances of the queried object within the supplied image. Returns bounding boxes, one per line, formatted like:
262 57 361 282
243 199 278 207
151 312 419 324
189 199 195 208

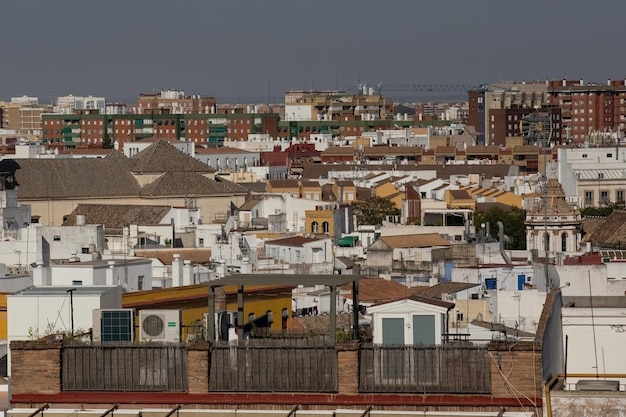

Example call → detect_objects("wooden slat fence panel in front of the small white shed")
359 345 491 394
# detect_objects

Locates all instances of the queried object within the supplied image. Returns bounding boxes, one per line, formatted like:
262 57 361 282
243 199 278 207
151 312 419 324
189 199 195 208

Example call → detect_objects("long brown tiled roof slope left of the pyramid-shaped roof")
12 158 140 200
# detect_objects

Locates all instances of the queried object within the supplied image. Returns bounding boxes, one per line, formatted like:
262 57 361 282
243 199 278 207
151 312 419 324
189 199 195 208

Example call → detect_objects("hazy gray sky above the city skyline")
0 0 626 102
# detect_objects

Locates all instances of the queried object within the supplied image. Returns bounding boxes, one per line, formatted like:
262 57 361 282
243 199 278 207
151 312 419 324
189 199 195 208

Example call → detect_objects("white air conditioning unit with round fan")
139 310 181 342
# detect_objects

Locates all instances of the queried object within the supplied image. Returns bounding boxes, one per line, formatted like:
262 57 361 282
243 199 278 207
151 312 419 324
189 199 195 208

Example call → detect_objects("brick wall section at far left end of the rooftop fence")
11 341 61 394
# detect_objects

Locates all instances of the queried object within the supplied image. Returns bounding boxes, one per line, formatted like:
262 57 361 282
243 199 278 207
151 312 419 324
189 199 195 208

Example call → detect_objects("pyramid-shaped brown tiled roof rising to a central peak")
131 139 215 173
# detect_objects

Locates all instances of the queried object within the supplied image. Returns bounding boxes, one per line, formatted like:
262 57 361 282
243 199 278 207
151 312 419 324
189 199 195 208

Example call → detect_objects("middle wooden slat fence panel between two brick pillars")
209 340 337 392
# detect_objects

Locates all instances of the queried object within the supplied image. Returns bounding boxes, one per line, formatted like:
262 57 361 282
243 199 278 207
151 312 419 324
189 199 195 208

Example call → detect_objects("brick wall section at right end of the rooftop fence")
489 342 542 400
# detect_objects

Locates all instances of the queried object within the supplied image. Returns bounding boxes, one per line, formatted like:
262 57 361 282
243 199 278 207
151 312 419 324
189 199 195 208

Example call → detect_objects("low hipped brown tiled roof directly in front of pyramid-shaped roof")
140 171 248 197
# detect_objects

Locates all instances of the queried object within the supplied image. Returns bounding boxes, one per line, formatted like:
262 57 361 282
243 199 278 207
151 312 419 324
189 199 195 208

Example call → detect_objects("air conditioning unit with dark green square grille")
92 308 135 343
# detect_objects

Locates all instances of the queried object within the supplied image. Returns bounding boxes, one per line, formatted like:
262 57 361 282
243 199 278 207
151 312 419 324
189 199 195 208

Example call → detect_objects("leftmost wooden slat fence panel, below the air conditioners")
61 343 187 391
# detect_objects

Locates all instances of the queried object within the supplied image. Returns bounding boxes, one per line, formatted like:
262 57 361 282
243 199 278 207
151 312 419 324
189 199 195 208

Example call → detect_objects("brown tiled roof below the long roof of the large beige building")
63 204 171 234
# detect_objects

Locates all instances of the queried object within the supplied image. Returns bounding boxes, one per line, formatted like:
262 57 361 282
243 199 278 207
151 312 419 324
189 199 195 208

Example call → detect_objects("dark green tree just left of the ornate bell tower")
474 207 526 249
